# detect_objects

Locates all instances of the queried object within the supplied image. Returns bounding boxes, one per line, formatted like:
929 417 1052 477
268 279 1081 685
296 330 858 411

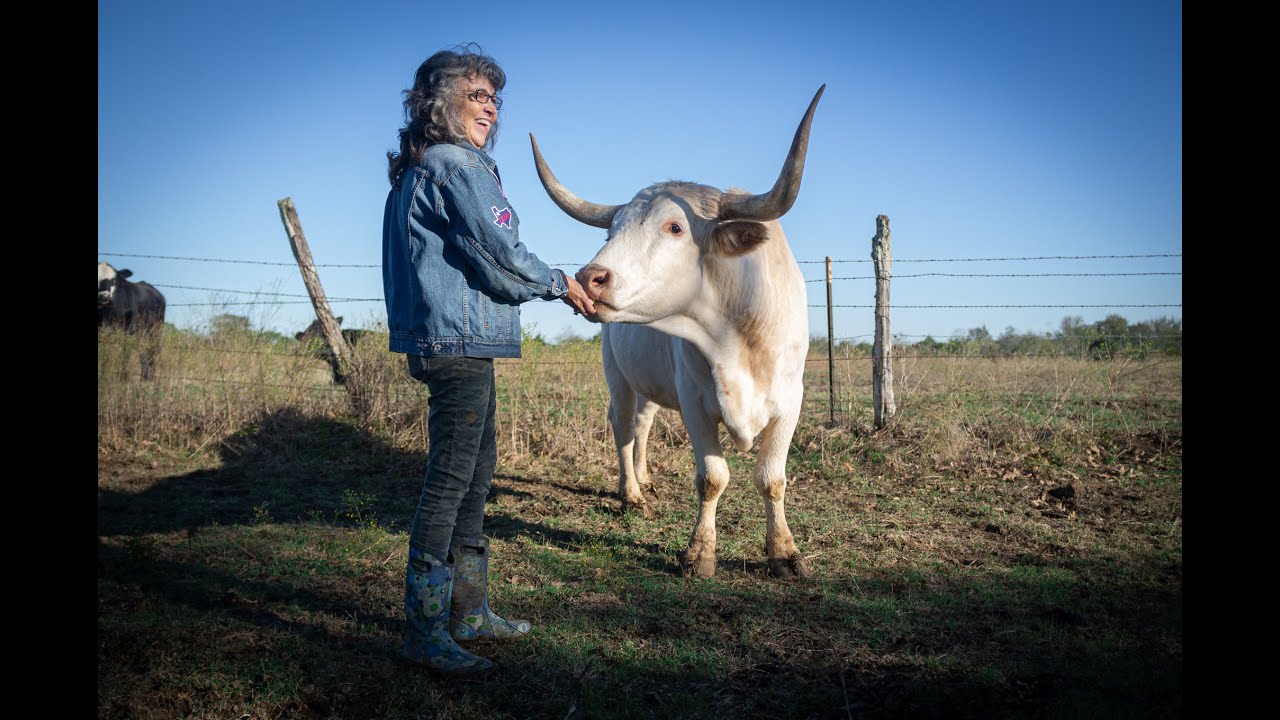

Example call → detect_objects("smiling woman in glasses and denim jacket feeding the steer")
383 45 594 674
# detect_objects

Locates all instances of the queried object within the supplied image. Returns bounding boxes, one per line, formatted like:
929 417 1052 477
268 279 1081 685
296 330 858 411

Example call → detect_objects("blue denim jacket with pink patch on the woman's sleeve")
383 143 568 357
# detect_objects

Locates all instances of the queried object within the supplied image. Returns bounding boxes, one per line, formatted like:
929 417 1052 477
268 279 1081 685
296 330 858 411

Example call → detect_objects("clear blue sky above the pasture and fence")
97 0 1183 338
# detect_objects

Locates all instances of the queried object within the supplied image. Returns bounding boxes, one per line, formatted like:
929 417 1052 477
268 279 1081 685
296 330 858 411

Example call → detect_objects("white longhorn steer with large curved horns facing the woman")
530 86 826 578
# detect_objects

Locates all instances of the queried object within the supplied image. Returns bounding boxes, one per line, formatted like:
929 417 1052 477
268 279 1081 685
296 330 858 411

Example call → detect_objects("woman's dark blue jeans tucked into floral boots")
408 355 498 561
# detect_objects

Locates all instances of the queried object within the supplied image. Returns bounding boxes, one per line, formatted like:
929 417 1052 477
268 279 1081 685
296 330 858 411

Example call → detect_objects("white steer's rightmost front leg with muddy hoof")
754 415 809 579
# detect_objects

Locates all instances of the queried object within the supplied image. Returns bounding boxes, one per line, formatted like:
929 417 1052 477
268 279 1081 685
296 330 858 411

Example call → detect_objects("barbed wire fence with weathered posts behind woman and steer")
99 213 1183 427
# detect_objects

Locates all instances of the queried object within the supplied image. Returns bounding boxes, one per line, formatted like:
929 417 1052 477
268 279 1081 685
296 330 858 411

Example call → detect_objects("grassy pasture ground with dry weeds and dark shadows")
97 329 1183 720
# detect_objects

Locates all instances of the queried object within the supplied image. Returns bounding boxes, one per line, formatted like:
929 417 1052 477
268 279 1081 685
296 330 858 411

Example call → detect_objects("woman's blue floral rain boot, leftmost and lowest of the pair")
401 548 493 675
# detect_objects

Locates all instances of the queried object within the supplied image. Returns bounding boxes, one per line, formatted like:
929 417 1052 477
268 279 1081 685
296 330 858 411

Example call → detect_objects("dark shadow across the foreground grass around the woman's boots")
97 413 1181 719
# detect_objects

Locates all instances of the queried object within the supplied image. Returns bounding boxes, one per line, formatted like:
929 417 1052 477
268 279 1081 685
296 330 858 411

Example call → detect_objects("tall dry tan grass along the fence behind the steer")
99 331 1181 464
